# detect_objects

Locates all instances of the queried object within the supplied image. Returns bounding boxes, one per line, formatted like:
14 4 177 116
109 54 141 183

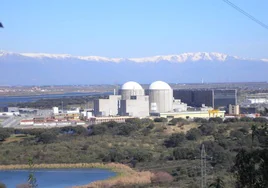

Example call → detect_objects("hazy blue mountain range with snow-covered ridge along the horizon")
0 51 268 85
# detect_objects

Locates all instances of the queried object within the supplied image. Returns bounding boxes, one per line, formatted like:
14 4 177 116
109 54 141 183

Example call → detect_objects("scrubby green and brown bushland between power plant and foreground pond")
0 118 268 188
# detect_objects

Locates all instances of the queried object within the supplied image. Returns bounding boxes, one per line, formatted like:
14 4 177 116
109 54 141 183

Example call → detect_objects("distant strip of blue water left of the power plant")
0 92 110 107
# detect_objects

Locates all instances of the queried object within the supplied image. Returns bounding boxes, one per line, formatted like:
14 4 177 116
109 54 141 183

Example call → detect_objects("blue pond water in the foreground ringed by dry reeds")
0 169 116 188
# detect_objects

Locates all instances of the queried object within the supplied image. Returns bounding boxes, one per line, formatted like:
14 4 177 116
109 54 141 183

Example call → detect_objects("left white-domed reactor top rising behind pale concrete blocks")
119 81 144 100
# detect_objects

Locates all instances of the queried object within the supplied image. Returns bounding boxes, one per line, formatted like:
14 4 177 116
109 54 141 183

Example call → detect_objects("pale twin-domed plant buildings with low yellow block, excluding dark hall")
94 81 225 119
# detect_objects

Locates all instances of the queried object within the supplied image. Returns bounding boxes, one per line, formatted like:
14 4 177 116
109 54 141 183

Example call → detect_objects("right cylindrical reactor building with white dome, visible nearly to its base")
149 81 173 113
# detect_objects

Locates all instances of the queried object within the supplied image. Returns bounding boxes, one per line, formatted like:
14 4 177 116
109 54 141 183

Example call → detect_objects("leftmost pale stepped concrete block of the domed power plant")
94 95 121 116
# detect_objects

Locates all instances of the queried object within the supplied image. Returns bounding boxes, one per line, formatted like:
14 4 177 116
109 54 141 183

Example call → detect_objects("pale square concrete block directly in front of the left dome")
120 95 149 117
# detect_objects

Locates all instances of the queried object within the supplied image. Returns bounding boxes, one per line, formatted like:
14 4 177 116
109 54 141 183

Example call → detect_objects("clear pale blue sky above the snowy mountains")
0 0 268 58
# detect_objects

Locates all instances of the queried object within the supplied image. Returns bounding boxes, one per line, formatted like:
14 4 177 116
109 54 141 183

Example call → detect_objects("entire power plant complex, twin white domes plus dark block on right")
93 81 226 119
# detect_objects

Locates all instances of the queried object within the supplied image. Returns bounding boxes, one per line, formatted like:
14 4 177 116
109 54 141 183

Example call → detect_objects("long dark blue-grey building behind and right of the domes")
173 89 237 109
